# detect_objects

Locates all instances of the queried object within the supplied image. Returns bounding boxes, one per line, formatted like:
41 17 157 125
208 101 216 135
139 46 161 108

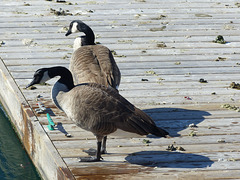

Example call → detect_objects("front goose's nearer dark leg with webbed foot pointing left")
79 136 103 162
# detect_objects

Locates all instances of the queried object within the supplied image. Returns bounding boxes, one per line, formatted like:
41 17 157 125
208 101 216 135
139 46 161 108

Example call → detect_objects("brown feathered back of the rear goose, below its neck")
70 45 121 89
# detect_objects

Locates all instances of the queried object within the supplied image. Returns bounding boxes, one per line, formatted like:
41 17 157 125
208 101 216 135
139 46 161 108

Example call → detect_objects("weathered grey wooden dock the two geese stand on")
0 0 240 180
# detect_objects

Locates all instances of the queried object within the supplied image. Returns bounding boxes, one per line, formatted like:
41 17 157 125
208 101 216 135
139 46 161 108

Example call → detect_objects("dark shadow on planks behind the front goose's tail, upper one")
144 108 211 137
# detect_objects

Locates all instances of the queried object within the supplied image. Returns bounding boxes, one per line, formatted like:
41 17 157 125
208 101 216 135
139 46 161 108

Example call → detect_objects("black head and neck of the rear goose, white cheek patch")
65 20 95 45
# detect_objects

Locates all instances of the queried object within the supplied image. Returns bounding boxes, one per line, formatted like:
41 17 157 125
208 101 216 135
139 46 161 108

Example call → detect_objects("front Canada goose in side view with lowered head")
27 66 168 162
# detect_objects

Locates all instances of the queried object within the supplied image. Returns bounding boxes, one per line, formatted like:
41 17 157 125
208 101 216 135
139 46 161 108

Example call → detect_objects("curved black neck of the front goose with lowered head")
48 66 74 91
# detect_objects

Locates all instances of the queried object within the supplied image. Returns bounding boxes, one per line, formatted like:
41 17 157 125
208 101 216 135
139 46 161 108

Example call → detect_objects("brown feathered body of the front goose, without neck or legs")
58 83 168 137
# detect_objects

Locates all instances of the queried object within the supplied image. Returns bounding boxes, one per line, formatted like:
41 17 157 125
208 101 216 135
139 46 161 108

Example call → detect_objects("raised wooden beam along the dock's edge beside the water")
0 58 75 180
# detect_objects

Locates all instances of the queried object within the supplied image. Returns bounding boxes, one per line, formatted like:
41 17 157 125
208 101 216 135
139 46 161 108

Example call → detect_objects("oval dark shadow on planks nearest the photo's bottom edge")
125 151 213 168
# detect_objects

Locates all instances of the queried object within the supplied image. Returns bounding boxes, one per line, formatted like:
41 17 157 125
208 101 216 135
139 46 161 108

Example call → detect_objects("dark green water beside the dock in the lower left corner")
0 105 41 180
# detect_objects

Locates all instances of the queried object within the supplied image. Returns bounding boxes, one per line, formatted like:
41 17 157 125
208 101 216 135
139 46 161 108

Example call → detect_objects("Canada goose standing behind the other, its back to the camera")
66 20 121 89
